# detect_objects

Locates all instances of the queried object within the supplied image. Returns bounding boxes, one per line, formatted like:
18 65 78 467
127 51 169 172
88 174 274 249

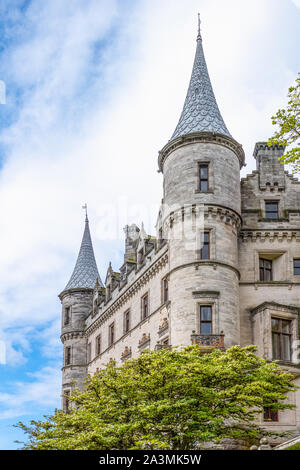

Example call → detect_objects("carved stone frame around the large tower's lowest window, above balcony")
192 291 221 335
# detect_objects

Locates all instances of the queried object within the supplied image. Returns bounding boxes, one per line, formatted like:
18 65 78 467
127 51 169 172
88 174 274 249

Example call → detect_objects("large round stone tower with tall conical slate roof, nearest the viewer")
158 19 245 348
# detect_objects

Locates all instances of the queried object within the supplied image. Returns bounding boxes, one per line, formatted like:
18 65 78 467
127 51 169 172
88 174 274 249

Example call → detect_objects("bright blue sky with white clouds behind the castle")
0 0 300 449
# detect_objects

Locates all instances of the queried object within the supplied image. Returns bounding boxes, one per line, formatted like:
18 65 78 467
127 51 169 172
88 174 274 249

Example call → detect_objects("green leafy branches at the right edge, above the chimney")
268 74 300 173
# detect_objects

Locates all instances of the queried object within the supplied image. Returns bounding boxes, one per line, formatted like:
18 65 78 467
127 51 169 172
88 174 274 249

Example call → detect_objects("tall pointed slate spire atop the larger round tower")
171 14 231 140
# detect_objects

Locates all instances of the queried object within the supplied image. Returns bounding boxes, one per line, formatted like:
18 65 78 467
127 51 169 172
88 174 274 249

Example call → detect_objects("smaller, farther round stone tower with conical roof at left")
59 211 103 410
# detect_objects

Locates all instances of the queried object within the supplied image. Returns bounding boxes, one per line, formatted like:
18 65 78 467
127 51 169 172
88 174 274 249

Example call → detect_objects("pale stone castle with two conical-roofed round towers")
59 18 300 434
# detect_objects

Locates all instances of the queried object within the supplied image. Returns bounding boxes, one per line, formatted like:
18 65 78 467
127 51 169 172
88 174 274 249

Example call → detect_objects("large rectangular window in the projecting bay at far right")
271 318 292 361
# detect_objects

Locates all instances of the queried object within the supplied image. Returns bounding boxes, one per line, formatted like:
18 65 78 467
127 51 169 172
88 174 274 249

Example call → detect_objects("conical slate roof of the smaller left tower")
64 217 103 290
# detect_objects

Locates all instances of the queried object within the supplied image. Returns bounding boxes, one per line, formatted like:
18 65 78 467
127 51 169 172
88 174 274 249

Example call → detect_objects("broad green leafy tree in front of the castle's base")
16 346 295 450
